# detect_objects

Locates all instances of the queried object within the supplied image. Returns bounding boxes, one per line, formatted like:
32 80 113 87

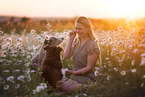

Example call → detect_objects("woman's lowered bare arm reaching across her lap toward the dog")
66 53 98 75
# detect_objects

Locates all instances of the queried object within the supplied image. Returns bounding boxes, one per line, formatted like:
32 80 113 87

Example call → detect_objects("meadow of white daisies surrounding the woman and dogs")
0 26 145 97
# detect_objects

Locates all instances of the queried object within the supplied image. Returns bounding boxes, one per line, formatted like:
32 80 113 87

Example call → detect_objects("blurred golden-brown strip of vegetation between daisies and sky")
0 16 145 34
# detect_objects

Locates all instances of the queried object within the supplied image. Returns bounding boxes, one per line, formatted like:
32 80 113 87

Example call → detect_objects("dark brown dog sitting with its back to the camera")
41 46 63 88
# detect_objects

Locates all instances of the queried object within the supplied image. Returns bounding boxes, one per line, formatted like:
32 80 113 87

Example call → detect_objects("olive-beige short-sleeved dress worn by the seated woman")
71 39 100 84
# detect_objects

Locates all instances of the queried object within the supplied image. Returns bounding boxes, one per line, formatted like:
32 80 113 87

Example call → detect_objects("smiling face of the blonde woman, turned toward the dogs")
75 23 88 38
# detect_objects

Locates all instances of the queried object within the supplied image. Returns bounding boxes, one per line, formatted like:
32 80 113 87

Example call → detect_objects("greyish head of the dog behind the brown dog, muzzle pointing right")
44 37 64 46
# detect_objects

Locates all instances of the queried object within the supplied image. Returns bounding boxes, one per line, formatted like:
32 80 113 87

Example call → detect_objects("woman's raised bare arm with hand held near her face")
63 31 76 59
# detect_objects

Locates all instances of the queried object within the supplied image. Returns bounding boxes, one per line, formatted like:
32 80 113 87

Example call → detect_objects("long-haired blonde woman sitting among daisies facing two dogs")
57 16 100 91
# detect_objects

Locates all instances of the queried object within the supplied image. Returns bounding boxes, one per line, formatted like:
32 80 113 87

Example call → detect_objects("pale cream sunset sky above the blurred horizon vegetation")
0 0 145 18
